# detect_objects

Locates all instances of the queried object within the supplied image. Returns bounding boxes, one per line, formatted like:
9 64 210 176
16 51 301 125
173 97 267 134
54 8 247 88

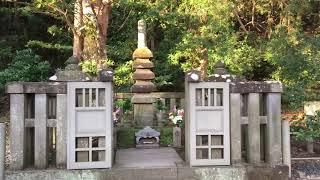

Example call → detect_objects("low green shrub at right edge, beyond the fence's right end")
291 111 320 142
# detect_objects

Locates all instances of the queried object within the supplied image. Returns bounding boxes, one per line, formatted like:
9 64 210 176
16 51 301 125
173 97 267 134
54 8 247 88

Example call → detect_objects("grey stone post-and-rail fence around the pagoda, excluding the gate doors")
6 82 290 173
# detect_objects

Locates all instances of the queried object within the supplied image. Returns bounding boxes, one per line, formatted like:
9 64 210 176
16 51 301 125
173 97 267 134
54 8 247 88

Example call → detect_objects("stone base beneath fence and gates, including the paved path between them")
5 148 288 180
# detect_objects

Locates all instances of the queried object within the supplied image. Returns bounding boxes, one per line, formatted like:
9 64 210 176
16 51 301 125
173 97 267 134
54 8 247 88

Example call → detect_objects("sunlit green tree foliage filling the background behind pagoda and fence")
0 0 320 107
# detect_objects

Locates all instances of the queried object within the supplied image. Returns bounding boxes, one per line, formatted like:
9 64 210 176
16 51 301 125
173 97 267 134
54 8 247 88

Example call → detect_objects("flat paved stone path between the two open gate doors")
115 147 183 168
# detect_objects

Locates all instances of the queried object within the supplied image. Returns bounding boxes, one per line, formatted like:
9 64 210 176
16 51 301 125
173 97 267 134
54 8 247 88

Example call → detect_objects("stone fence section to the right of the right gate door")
230 82 290 166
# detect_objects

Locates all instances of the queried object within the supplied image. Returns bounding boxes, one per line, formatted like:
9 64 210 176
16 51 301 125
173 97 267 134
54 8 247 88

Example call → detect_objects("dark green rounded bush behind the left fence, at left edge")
0 49 50 86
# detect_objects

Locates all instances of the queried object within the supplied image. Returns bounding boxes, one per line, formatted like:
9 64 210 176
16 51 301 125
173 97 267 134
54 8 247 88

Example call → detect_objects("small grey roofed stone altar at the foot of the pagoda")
135 126 160 148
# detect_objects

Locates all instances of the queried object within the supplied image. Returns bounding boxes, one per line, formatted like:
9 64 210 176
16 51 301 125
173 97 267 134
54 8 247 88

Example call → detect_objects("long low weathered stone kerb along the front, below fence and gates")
6 166 288 180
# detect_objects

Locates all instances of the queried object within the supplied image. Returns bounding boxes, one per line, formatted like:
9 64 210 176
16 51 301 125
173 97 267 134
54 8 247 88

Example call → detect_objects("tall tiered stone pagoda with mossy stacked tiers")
131 20 155 126
